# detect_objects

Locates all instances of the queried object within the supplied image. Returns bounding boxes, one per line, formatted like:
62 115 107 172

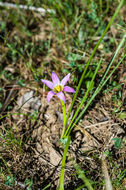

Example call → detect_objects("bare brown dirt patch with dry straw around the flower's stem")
2 85 126 189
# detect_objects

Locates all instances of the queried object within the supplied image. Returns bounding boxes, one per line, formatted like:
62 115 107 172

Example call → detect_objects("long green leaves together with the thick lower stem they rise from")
43 0 126 187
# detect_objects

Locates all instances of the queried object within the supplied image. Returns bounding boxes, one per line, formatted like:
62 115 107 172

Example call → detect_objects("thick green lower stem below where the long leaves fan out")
59 136 71 190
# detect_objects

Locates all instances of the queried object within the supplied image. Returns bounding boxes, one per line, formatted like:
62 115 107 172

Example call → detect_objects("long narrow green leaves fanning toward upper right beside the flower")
60 0 126 190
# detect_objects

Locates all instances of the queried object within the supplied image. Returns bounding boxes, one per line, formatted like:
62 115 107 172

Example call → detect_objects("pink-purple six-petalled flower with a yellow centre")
41 72 75 103
